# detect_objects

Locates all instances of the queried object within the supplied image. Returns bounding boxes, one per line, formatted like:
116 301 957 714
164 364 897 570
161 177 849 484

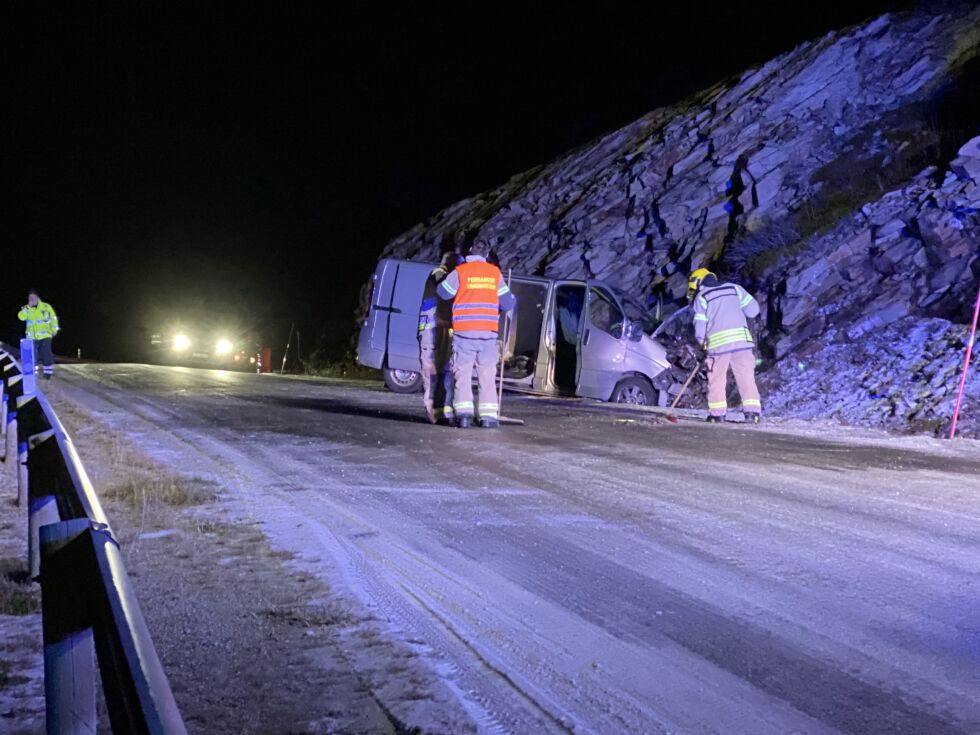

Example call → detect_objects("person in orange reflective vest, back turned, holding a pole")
437 240 517 429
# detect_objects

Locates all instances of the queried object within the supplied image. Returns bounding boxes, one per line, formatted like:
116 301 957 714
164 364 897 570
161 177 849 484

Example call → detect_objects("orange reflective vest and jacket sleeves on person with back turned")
437 255 516 337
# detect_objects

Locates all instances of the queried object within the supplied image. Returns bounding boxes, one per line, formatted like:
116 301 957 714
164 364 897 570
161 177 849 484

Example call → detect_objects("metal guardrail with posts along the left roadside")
0 340 187 735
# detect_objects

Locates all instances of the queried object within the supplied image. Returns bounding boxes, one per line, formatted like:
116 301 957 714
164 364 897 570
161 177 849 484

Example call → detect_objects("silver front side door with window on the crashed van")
576 281 627 401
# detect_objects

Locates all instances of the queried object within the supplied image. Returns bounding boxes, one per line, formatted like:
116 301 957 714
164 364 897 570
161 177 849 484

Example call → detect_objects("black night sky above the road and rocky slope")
0 1 910 359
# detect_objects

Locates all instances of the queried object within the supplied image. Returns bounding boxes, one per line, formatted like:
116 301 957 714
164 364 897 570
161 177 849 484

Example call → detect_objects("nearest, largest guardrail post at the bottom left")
40 518 98 735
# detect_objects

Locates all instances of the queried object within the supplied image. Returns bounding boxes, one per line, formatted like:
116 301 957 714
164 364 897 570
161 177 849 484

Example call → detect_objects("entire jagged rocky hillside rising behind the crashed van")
384 3 980 431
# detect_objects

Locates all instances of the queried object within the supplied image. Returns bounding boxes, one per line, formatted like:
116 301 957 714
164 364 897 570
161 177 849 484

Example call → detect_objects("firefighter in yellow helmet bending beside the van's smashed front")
687 268 762 424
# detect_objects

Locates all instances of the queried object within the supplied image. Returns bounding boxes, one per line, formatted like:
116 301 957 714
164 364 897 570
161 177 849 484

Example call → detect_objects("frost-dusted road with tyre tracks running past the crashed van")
58 365 980 735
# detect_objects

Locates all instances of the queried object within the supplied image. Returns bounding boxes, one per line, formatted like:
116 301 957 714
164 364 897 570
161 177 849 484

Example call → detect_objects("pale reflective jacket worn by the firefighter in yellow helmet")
694 283 759 355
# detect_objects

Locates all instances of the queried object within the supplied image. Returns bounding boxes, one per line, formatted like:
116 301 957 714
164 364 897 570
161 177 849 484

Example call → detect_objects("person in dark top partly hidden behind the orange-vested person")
419 251 459 424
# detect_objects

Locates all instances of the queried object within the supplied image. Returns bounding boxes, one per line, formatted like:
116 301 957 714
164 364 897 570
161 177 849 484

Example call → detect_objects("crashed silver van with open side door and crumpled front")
357 259 672 405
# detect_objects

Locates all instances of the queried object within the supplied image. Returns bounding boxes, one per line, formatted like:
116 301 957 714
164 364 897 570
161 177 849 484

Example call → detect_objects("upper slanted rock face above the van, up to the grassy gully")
384 10 980 298
